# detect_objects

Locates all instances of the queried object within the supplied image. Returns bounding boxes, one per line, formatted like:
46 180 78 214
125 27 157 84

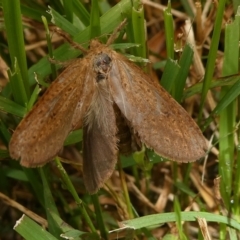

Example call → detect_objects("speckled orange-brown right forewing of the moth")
109 54 207 162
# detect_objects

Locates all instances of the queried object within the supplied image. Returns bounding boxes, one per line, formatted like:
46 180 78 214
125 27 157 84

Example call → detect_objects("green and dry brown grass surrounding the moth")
0 0 240 239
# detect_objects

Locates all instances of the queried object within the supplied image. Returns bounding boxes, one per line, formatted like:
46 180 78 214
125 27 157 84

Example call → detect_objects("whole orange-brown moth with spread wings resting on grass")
9 20 207 193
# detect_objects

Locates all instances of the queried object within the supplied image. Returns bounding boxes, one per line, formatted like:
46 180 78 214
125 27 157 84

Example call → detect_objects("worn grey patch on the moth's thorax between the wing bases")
93 53 112 82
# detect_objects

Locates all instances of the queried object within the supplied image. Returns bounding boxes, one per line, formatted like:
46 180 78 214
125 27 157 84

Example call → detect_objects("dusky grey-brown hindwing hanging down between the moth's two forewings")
83 90 118 194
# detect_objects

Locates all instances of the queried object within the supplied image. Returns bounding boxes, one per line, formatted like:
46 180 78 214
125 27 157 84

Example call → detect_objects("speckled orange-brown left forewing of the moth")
9 59 93 167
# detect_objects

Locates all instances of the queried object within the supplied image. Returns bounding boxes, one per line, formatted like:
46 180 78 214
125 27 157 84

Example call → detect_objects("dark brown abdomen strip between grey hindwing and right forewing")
114 105 132 155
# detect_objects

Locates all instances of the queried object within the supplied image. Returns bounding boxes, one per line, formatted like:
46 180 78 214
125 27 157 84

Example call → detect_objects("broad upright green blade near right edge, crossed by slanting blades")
219 10 239 209
